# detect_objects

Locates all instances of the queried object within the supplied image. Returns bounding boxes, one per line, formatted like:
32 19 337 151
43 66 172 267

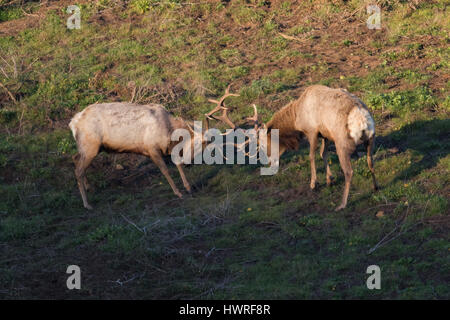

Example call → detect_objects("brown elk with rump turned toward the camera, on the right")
248 85 378 211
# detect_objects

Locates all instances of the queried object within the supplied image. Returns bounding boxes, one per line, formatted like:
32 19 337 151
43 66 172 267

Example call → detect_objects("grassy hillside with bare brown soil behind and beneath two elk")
0 0 450 299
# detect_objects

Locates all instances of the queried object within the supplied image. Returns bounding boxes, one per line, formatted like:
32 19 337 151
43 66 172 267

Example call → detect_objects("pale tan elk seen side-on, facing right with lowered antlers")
69 87 237 209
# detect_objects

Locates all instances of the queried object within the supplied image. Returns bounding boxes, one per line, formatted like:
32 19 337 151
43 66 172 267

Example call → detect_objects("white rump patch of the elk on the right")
347 107 375 144
